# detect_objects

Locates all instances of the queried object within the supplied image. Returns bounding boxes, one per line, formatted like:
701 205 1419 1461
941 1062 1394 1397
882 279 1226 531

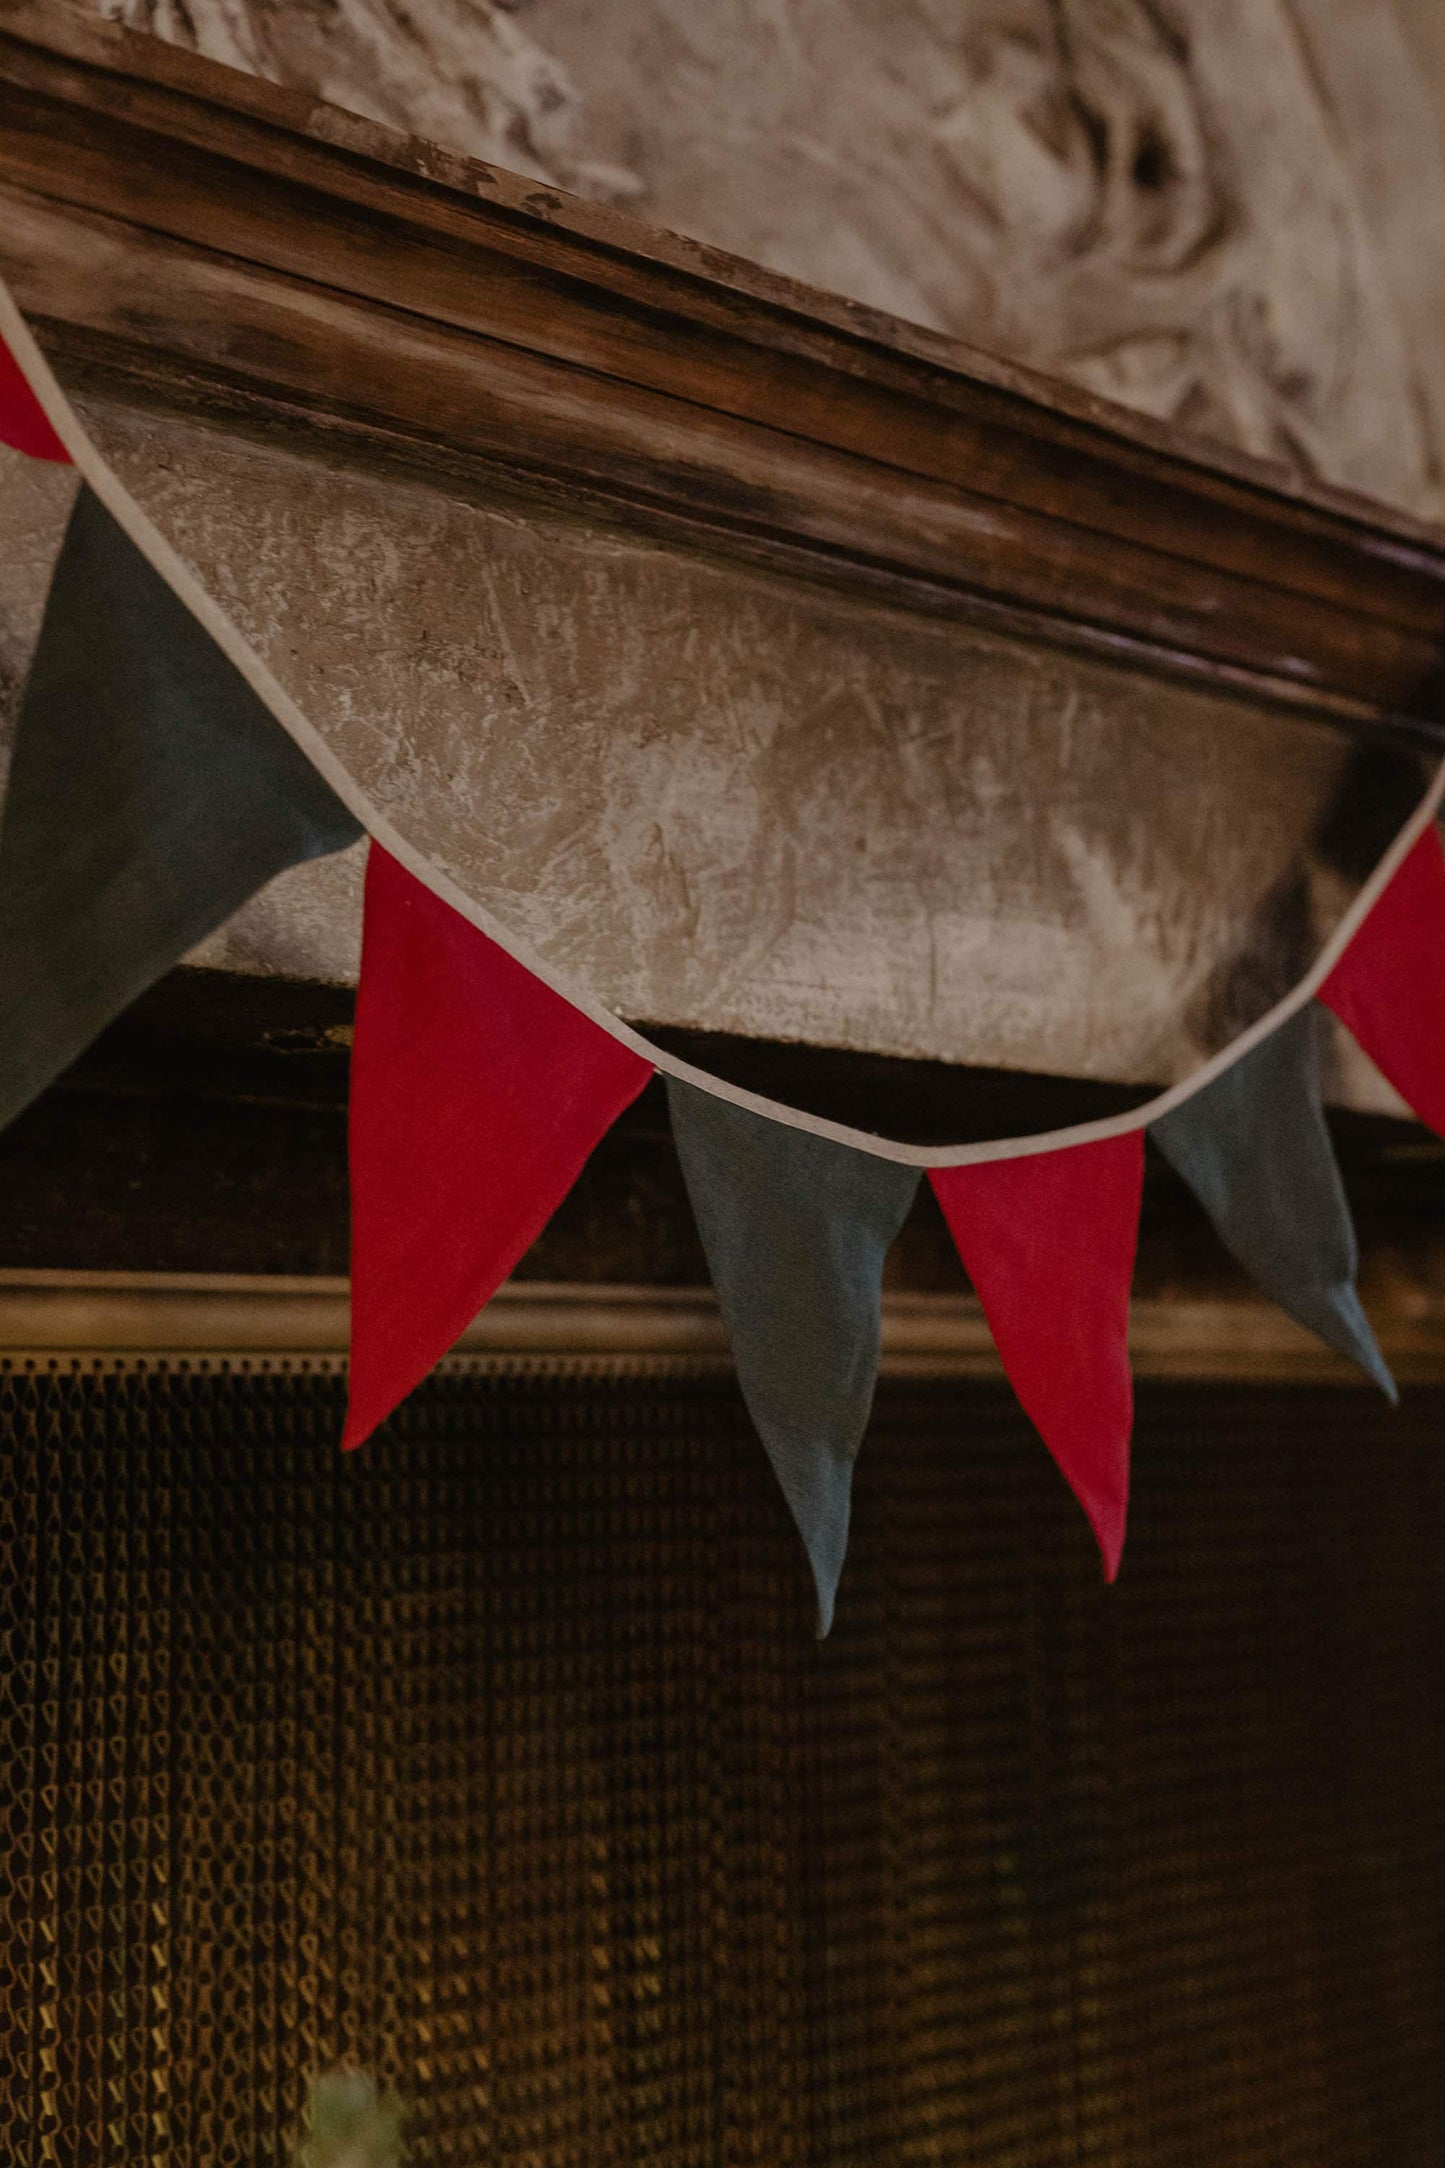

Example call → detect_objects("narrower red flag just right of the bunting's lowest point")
929 1130 1144 1580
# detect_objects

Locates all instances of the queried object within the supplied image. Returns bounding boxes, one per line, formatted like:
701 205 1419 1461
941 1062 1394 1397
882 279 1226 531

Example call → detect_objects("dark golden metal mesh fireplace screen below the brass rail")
0 1364 1445 2168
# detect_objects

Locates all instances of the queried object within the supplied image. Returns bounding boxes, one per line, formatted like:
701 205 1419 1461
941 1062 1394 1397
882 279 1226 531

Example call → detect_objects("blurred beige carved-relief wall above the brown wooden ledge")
102 0 1445 516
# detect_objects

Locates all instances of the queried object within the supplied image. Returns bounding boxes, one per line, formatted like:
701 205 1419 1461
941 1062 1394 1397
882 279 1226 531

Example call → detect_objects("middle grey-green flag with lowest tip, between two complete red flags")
667 1077 919 1635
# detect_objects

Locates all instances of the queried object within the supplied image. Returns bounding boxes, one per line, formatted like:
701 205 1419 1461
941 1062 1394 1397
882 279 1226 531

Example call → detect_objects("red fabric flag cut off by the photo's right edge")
1319 822 1445 1136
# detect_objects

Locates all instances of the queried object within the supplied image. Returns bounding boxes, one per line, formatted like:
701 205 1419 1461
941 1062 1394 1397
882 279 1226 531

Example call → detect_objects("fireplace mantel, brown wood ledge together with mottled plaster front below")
0 0 1445 1106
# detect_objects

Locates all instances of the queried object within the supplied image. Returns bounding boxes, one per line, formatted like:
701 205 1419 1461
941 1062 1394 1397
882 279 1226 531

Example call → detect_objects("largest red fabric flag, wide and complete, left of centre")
342 843 652 1446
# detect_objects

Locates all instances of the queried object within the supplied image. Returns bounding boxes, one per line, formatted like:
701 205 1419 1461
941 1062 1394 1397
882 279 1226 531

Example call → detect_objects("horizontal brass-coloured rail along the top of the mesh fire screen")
0 1270 1445 1385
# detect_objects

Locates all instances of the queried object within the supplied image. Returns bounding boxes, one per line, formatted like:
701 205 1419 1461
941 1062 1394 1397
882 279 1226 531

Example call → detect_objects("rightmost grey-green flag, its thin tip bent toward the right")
1148 1006 1395 1401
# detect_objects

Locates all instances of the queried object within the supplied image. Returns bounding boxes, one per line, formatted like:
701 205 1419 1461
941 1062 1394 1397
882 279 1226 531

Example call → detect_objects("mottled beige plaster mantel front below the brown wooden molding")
6 401 1345 1080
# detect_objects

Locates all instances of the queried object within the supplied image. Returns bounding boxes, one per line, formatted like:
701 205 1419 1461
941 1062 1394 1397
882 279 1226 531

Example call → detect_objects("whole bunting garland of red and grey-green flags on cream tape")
0 288 1445 1633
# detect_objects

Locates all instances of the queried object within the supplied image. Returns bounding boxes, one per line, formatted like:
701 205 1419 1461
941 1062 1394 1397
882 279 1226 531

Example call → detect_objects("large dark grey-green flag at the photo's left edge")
0 488 362 1123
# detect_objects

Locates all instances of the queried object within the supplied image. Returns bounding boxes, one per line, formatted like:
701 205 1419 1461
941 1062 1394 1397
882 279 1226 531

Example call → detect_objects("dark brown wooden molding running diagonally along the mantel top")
0 0 1445 737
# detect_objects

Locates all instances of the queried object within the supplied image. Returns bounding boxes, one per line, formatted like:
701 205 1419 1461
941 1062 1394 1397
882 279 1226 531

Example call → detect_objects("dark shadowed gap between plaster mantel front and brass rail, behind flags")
0 971 1445 1292
